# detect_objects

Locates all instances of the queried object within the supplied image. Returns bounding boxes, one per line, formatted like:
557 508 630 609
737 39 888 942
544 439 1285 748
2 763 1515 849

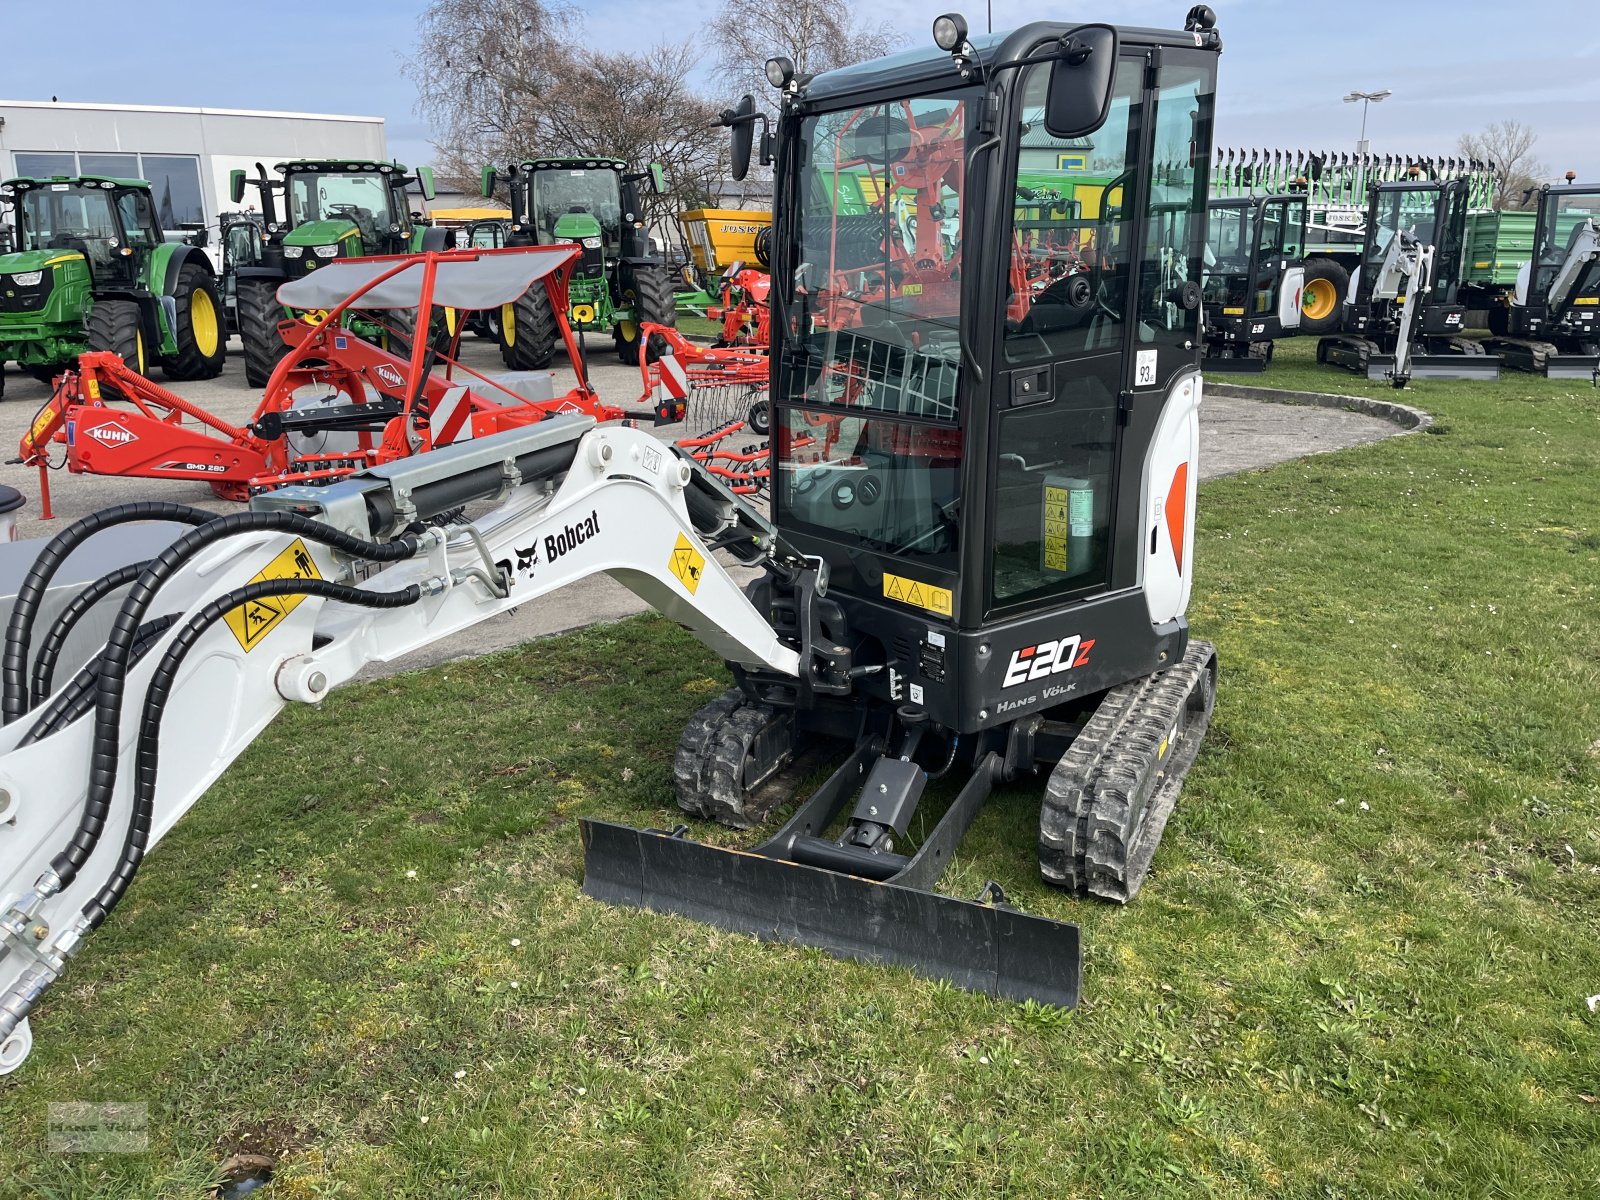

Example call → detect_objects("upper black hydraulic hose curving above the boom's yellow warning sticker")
45 512 421 891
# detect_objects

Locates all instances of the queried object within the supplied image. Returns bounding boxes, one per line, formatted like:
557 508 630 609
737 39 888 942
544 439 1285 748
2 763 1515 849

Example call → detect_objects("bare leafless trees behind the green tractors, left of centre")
405 0 726 218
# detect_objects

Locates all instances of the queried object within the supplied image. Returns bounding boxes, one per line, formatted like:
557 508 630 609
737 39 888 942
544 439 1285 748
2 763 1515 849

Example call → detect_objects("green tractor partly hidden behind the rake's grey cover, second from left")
227 158 448 387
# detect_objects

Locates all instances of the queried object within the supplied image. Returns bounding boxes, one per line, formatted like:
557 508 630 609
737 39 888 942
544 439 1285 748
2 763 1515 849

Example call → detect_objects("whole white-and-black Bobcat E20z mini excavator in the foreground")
0 5 1221 1072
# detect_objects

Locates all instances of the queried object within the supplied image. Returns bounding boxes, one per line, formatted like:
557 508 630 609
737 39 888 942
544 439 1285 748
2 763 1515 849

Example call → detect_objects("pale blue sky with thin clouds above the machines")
0 0 1600 182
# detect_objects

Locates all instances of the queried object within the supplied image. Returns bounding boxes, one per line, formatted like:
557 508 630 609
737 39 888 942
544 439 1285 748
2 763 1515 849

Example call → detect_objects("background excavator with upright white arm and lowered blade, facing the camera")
1317 178 1499 387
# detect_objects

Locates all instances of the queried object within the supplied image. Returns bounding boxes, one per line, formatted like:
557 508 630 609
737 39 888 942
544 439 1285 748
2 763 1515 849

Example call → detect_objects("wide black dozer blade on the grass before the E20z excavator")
581 819 1083 1008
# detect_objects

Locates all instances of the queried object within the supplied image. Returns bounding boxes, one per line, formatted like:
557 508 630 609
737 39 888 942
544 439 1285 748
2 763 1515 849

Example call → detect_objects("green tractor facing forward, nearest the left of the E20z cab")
483 158 677 371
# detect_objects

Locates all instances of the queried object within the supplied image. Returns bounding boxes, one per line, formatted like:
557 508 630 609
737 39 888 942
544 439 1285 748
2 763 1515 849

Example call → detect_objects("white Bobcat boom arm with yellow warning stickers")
0 418 798 1074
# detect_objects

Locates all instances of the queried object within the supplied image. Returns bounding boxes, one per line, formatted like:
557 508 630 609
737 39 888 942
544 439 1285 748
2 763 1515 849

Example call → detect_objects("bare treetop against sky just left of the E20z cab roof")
710 0 904 109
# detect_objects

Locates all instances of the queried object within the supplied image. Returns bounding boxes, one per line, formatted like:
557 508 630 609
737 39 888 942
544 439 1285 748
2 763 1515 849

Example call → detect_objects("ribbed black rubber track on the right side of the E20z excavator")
1038 642 1216 904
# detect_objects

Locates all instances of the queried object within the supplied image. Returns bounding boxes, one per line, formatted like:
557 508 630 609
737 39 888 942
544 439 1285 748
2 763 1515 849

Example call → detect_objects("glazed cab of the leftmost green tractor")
3 176 166 288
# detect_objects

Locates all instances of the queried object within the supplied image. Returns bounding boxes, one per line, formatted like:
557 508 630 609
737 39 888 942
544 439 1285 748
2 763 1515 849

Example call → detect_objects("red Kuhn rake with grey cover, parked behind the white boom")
19 246 624 517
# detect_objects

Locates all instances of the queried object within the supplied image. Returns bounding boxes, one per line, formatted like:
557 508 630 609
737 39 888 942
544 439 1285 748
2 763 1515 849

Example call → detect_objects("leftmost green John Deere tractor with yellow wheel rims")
0 176 226 395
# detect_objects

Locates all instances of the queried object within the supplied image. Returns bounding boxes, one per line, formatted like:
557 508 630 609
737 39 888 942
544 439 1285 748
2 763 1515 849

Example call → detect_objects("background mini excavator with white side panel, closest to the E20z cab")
1202 194 1306 371
